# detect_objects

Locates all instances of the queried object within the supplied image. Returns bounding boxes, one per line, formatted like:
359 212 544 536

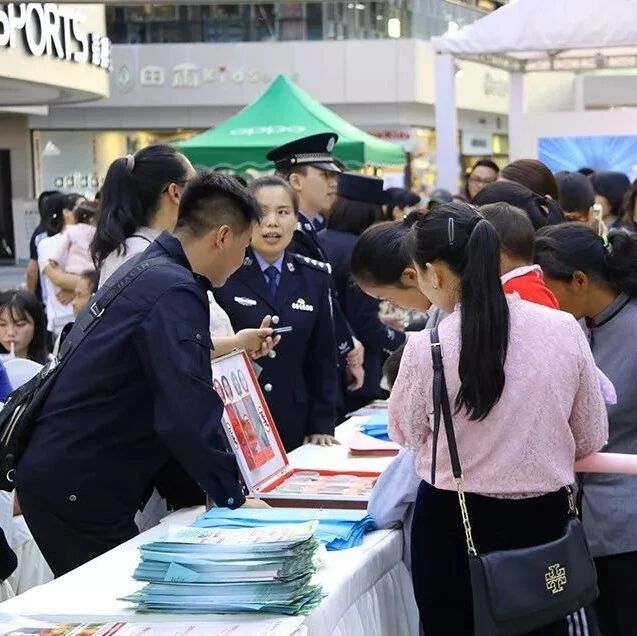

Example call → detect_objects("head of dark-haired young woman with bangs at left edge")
0 289 49 364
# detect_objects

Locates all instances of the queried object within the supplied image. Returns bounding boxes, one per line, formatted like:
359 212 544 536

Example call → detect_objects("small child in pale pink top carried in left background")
52 201 98 274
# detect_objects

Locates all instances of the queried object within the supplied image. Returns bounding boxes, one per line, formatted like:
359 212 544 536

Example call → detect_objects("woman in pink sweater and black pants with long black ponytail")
389 203 608 636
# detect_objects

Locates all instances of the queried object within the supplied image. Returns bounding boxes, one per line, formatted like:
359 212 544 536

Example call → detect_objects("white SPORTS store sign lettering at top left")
0 2 111 69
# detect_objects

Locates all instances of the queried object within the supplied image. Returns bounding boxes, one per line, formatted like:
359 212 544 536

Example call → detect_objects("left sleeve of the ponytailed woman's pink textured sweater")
389 330 432 450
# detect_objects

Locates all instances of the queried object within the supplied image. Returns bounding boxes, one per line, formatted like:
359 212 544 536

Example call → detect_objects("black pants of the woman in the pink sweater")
411 481 569 636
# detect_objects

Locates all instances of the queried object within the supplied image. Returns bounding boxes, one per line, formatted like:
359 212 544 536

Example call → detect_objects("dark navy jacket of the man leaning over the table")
16 233 244 533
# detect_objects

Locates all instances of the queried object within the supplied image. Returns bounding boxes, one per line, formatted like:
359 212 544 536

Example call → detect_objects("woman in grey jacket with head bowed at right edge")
535 223 637 636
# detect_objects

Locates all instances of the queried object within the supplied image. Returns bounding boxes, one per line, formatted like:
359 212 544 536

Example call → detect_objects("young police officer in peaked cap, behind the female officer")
267 133 364 404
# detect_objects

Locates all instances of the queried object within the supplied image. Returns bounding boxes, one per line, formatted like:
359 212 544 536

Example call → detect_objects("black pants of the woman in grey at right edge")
595 552 637 636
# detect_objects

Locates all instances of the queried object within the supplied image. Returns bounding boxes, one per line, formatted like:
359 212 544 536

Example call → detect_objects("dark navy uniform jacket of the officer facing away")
318 230 405 408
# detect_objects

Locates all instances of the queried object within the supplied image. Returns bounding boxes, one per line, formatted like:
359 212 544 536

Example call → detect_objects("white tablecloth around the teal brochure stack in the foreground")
0 508 418 636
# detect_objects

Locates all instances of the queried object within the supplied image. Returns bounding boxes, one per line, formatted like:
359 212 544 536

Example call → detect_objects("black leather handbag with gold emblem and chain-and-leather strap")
431 329 599 636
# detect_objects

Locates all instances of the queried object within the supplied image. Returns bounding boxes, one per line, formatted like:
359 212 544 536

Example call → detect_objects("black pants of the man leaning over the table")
18 490 138 577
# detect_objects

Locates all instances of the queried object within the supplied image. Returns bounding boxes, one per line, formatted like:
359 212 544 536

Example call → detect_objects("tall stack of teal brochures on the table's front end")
125 511 324 615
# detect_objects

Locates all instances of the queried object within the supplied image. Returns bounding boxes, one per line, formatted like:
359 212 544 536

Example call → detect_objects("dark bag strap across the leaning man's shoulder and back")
58 256 175 364
